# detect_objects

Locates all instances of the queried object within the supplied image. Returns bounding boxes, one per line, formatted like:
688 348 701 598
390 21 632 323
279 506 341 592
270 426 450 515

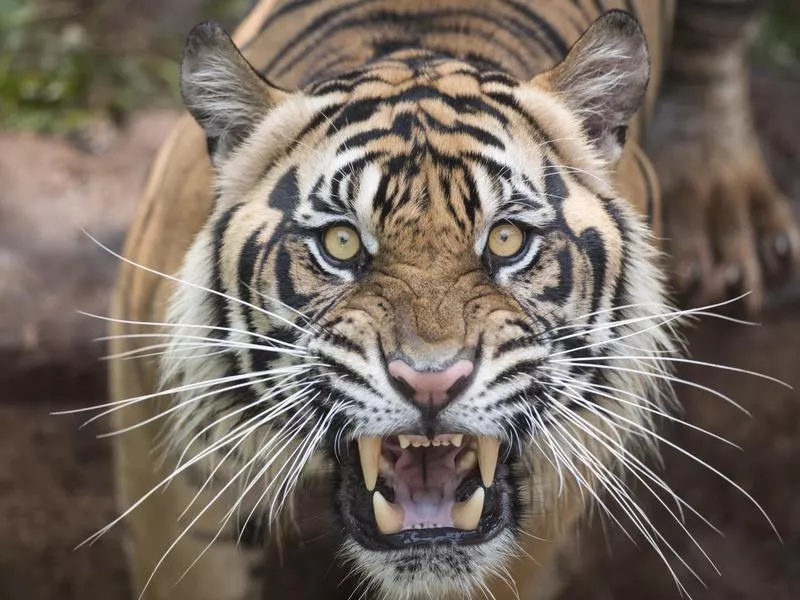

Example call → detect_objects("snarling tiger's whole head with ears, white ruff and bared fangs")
169 13 671 598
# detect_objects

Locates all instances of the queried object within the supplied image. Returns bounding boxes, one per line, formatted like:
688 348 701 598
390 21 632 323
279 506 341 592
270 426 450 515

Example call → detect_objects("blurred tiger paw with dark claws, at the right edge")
663 148 800 314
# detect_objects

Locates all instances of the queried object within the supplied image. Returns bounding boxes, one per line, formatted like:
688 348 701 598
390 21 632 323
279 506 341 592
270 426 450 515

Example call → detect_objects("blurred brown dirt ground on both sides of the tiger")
0 74 800 600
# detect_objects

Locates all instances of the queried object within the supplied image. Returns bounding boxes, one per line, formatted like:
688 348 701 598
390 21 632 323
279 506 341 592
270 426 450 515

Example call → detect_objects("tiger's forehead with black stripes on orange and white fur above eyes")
290 74 564 252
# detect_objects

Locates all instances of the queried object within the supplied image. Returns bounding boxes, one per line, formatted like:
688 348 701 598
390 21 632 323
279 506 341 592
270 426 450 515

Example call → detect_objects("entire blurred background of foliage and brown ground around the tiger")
0 0 800 600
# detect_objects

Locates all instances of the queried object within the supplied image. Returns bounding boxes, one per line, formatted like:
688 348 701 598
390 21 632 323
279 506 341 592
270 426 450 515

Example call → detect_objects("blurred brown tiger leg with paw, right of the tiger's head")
649 0 800 311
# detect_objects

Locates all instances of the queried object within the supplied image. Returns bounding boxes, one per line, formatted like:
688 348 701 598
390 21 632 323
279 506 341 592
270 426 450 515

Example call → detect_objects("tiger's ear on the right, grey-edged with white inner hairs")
533 10 650 165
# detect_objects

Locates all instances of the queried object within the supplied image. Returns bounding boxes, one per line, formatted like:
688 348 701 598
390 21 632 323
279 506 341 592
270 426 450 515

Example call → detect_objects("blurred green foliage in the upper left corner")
0 0 246 133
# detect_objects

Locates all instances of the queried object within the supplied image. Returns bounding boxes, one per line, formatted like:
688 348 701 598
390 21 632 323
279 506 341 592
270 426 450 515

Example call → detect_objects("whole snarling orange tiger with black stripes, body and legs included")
101 0 798 600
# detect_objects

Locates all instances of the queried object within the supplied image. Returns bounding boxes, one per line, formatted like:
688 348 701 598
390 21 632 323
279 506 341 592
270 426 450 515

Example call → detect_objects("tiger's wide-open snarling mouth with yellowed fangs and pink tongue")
339 434 514 549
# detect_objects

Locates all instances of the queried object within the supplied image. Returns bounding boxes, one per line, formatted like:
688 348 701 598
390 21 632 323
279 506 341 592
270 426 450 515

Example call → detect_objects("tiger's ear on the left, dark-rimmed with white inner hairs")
181 22 287 162
